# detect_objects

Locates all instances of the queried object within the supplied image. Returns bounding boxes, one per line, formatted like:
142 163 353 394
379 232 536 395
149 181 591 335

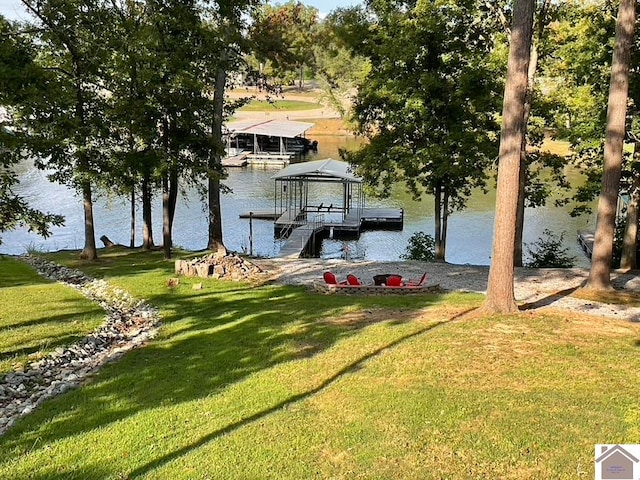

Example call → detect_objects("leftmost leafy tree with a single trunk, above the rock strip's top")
16 0 111 260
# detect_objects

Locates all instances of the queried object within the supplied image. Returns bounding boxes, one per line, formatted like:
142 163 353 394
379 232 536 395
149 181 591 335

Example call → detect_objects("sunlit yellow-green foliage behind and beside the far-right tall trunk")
540 0 640 216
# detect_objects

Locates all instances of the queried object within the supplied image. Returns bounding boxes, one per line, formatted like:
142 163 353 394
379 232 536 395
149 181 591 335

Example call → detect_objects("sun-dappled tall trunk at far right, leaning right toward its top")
585 0 636 291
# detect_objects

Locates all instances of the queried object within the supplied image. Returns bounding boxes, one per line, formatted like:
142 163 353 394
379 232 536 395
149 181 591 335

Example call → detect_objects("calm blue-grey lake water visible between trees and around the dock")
0 137 594 266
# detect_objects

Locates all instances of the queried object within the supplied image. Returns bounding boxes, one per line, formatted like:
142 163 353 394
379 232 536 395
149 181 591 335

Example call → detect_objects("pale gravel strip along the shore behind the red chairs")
254 259 640 322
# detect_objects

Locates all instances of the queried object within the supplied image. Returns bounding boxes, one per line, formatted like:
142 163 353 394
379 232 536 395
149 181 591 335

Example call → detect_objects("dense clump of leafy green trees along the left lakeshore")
0 0 258 257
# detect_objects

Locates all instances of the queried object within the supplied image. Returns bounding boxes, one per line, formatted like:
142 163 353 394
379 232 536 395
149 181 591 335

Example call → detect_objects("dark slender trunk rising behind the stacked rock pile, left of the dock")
207 68 227 255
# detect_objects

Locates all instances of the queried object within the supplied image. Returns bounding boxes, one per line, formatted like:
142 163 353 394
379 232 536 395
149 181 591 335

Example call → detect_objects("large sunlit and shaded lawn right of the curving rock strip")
0 249 640 479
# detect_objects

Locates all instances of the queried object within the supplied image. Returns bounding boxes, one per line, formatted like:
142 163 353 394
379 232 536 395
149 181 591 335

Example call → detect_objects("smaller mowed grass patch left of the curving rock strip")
0 255 105 375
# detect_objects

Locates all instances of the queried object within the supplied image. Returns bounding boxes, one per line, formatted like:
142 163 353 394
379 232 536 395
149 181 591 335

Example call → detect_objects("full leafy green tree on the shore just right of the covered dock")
343 1 498 260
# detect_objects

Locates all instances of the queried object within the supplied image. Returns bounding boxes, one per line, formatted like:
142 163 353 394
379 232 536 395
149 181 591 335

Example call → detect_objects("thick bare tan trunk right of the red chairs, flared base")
483 0 535 313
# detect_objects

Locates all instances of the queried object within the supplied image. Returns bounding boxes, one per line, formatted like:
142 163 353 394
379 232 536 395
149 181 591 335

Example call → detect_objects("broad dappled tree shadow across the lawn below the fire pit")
2 274 450 458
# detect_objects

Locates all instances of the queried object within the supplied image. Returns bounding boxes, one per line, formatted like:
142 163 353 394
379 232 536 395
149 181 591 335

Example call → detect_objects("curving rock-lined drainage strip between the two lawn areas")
0 256 159 435
